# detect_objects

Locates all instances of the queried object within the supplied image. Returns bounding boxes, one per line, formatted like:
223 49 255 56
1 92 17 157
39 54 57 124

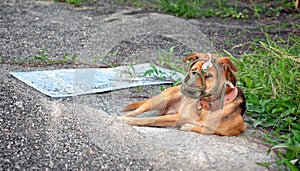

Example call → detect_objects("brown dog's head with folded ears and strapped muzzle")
181 52 237 100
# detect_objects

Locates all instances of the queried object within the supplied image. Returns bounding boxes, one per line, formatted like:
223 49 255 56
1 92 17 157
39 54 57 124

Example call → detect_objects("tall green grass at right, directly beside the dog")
226 34 300 170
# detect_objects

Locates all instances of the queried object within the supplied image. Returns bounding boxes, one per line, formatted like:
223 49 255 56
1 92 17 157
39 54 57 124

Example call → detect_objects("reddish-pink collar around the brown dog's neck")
199 87 238 111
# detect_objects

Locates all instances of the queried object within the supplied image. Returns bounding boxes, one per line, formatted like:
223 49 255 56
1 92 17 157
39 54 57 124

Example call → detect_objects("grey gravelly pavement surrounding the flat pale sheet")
0 0 277 170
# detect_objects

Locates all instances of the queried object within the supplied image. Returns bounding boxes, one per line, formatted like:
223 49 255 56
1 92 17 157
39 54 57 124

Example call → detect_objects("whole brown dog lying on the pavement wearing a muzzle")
119 52 247 136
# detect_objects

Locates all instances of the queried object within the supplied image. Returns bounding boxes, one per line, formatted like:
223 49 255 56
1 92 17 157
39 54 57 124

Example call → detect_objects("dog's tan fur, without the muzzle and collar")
119 52 247 136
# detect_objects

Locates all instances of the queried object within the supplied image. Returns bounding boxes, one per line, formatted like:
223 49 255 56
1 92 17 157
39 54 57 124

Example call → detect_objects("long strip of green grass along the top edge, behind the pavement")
117 0 294 19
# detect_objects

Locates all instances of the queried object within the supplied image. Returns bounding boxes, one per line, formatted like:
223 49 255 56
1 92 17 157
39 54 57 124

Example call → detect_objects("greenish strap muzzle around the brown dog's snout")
180 58 221 99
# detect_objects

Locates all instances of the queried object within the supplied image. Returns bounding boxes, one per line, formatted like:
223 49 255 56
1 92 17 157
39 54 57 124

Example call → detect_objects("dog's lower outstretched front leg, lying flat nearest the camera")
118 114 181 127
